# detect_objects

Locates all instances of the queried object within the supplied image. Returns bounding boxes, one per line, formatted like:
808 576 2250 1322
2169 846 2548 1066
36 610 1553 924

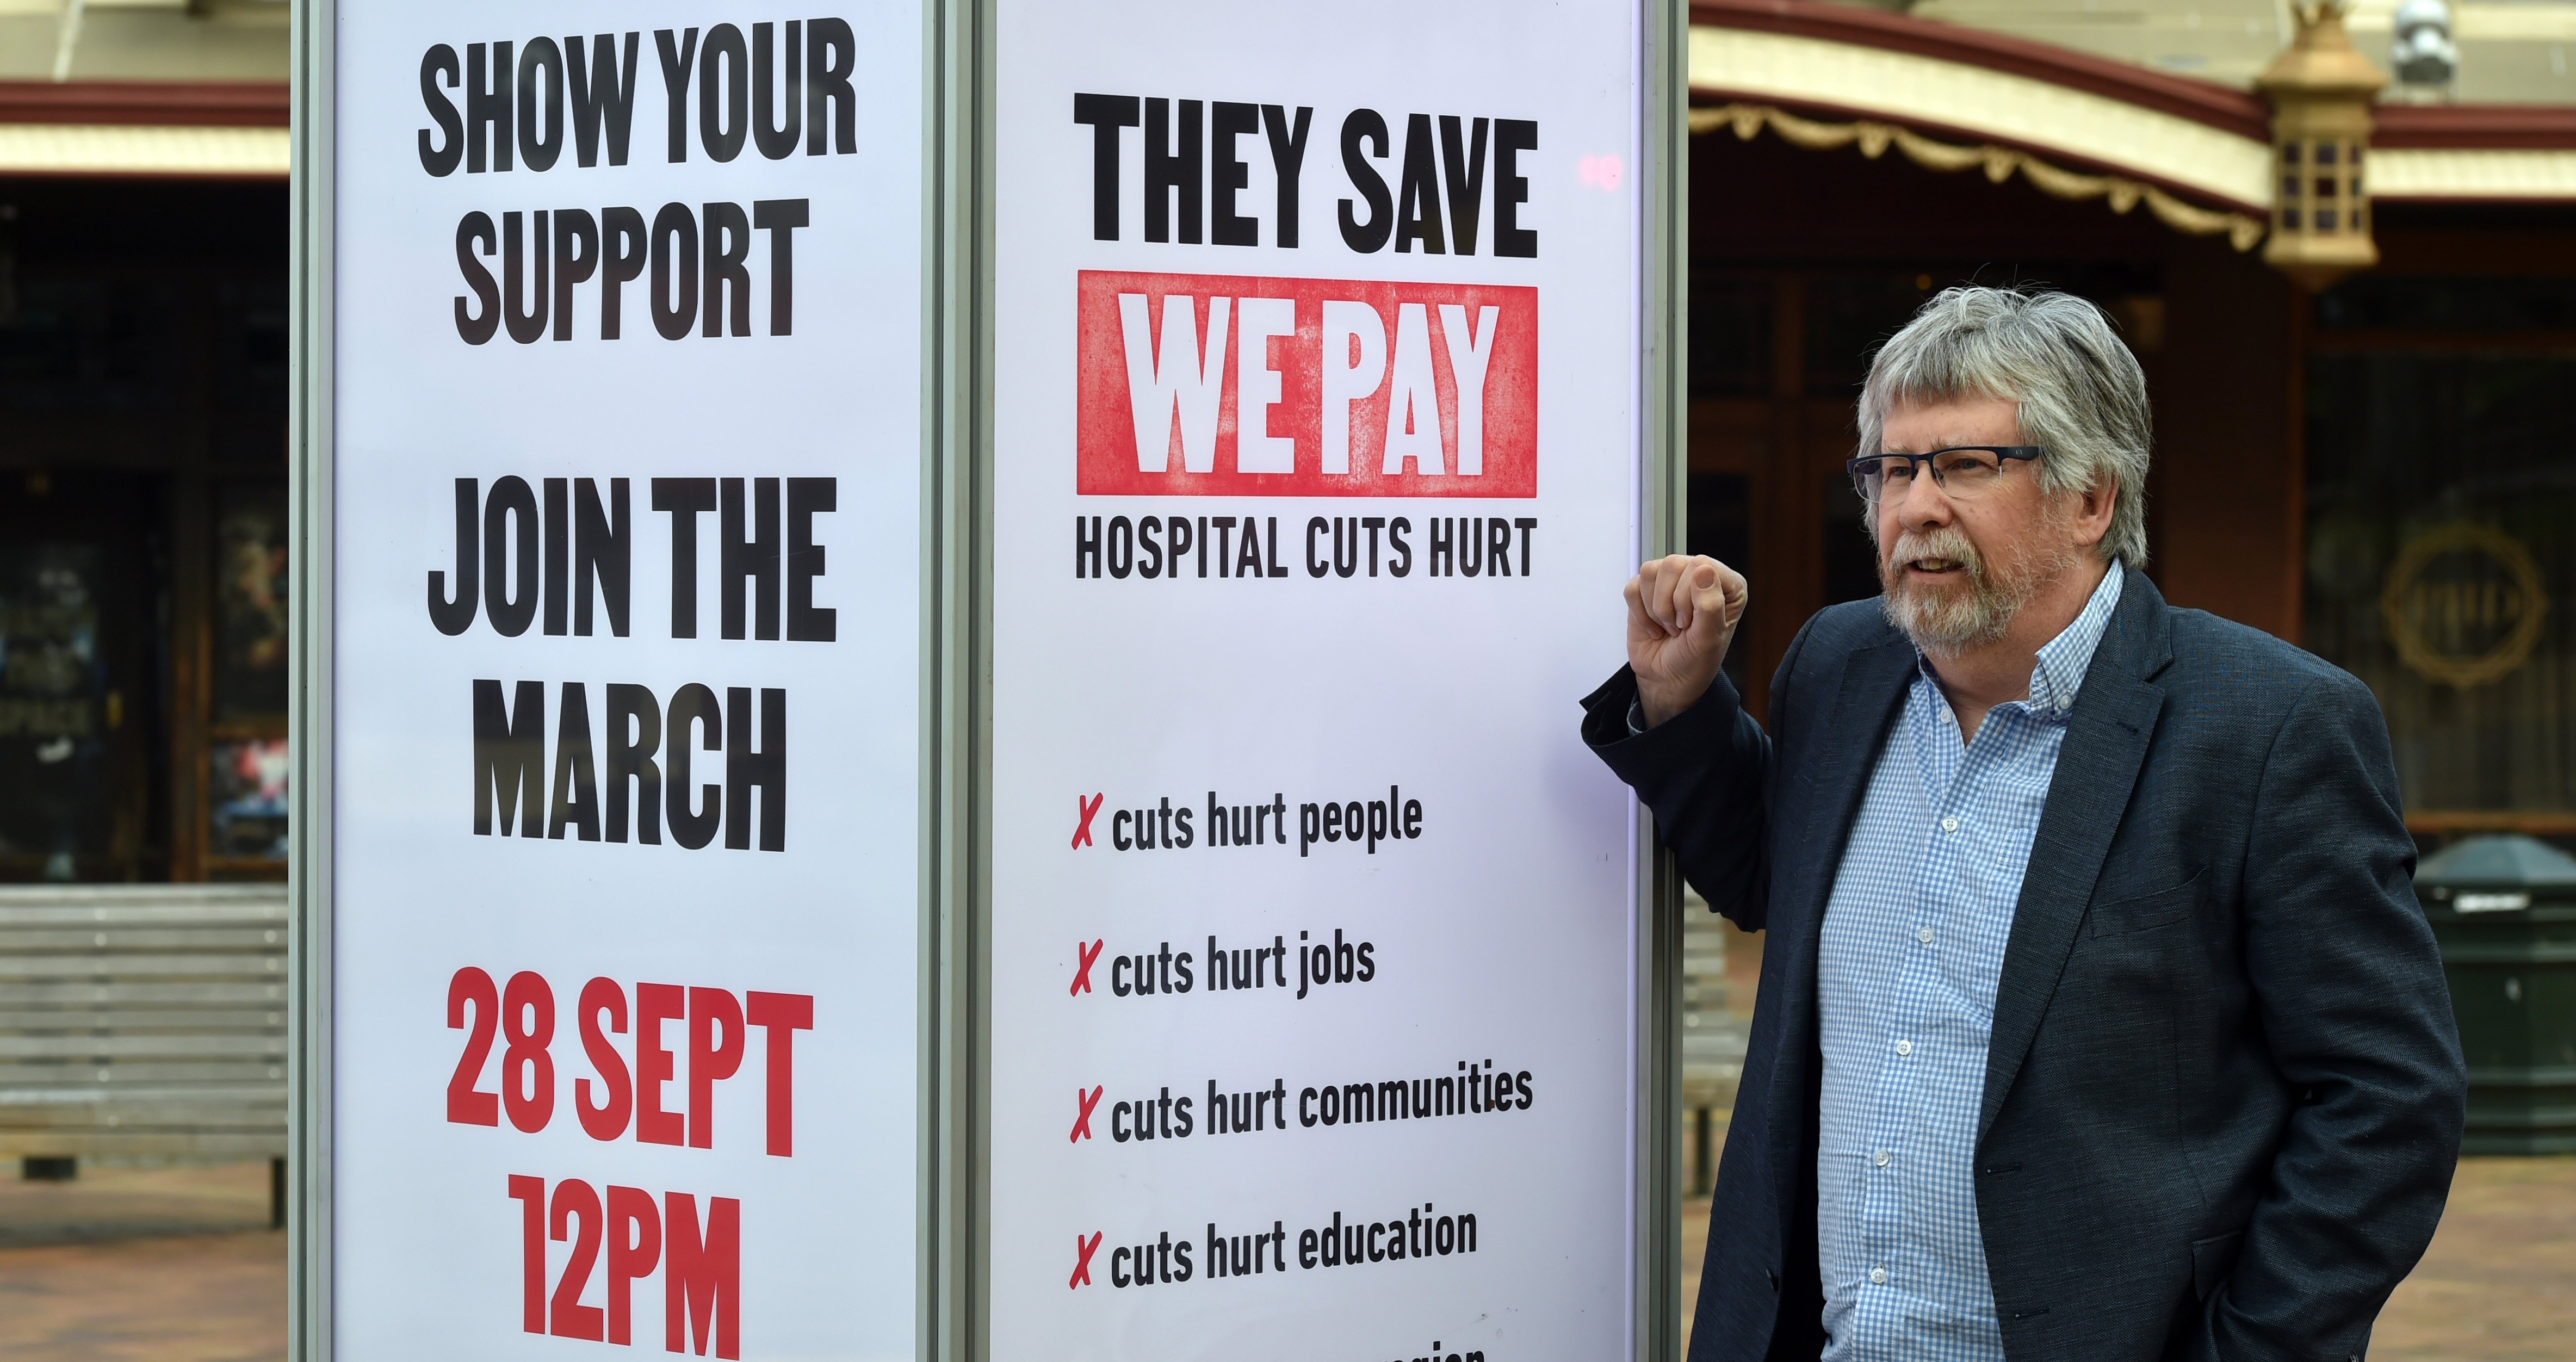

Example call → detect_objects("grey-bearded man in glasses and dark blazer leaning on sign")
1584 288 2465 1362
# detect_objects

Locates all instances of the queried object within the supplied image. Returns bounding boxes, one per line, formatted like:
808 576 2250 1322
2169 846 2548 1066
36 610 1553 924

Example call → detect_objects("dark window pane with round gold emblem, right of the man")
2303 350 2576 811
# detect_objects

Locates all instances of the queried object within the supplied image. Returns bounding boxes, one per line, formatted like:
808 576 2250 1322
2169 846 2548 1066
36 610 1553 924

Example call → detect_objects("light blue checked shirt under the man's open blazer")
1816 569 2120 1362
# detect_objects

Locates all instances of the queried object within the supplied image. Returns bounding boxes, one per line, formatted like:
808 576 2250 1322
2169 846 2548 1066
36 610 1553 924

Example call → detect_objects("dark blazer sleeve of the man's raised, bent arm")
1584 628 1806 932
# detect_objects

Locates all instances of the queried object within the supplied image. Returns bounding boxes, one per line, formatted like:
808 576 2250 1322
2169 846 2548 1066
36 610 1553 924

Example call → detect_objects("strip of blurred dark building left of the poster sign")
0 0 288 881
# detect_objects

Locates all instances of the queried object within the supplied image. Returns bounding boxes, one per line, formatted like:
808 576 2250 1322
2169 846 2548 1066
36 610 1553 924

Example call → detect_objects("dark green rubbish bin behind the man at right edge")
2416 837 2576 1154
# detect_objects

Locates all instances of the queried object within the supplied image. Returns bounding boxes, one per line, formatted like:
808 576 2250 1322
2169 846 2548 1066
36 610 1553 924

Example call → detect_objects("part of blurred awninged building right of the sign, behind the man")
1690 0 2576 847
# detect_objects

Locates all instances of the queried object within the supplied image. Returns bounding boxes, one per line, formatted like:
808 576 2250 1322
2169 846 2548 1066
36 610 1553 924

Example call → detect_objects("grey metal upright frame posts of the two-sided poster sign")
288 0 1690 1362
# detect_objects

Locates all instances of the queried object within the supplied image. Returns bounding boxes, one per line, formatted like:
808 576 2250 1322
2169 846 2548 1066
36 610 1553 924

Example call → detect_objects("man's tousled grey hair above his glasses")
1860 283 2153 566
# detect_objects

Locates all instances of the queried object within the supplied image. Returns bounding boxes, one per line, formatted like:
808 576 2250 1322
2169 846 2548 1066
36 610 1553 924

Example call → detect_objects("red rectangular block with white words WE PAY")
1074 270 1538 497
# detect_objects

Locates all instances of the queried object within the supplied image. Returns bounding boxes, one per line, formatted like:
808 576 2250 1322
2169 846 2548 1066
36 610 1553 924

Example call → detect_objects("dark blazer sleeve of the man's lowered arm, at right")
2202 672 2468 1359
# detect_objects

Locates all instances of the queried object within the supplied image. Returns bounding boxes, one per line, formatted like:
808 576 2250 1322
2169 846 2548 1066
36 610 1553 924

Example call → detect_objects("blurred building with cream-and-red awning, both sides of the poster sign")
0 0 2576 881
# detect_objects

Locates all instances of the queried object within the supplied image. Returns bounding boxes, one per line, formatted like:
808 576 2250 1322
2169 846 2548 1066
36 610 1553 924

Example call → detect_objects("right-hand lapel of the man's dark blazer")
1976 569 2171 1141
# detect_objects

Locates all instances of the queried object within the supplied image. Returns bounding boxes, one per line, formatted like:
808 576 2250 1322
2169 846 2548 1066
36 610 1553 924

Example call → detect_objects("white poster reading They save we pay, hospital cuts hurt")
987 0 1641 1362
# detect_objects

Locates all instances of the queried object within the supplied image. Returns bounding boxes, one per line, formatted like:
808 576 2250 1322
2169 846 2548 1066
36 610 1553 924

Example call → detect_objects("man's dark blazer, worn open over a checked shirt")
1584 569 2465 1362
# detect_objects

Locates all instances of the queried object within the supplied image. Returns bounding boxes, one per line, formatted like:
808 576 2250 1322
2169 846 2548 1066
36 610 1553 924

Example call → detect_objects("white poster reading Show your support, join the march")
330 0 922 1359
